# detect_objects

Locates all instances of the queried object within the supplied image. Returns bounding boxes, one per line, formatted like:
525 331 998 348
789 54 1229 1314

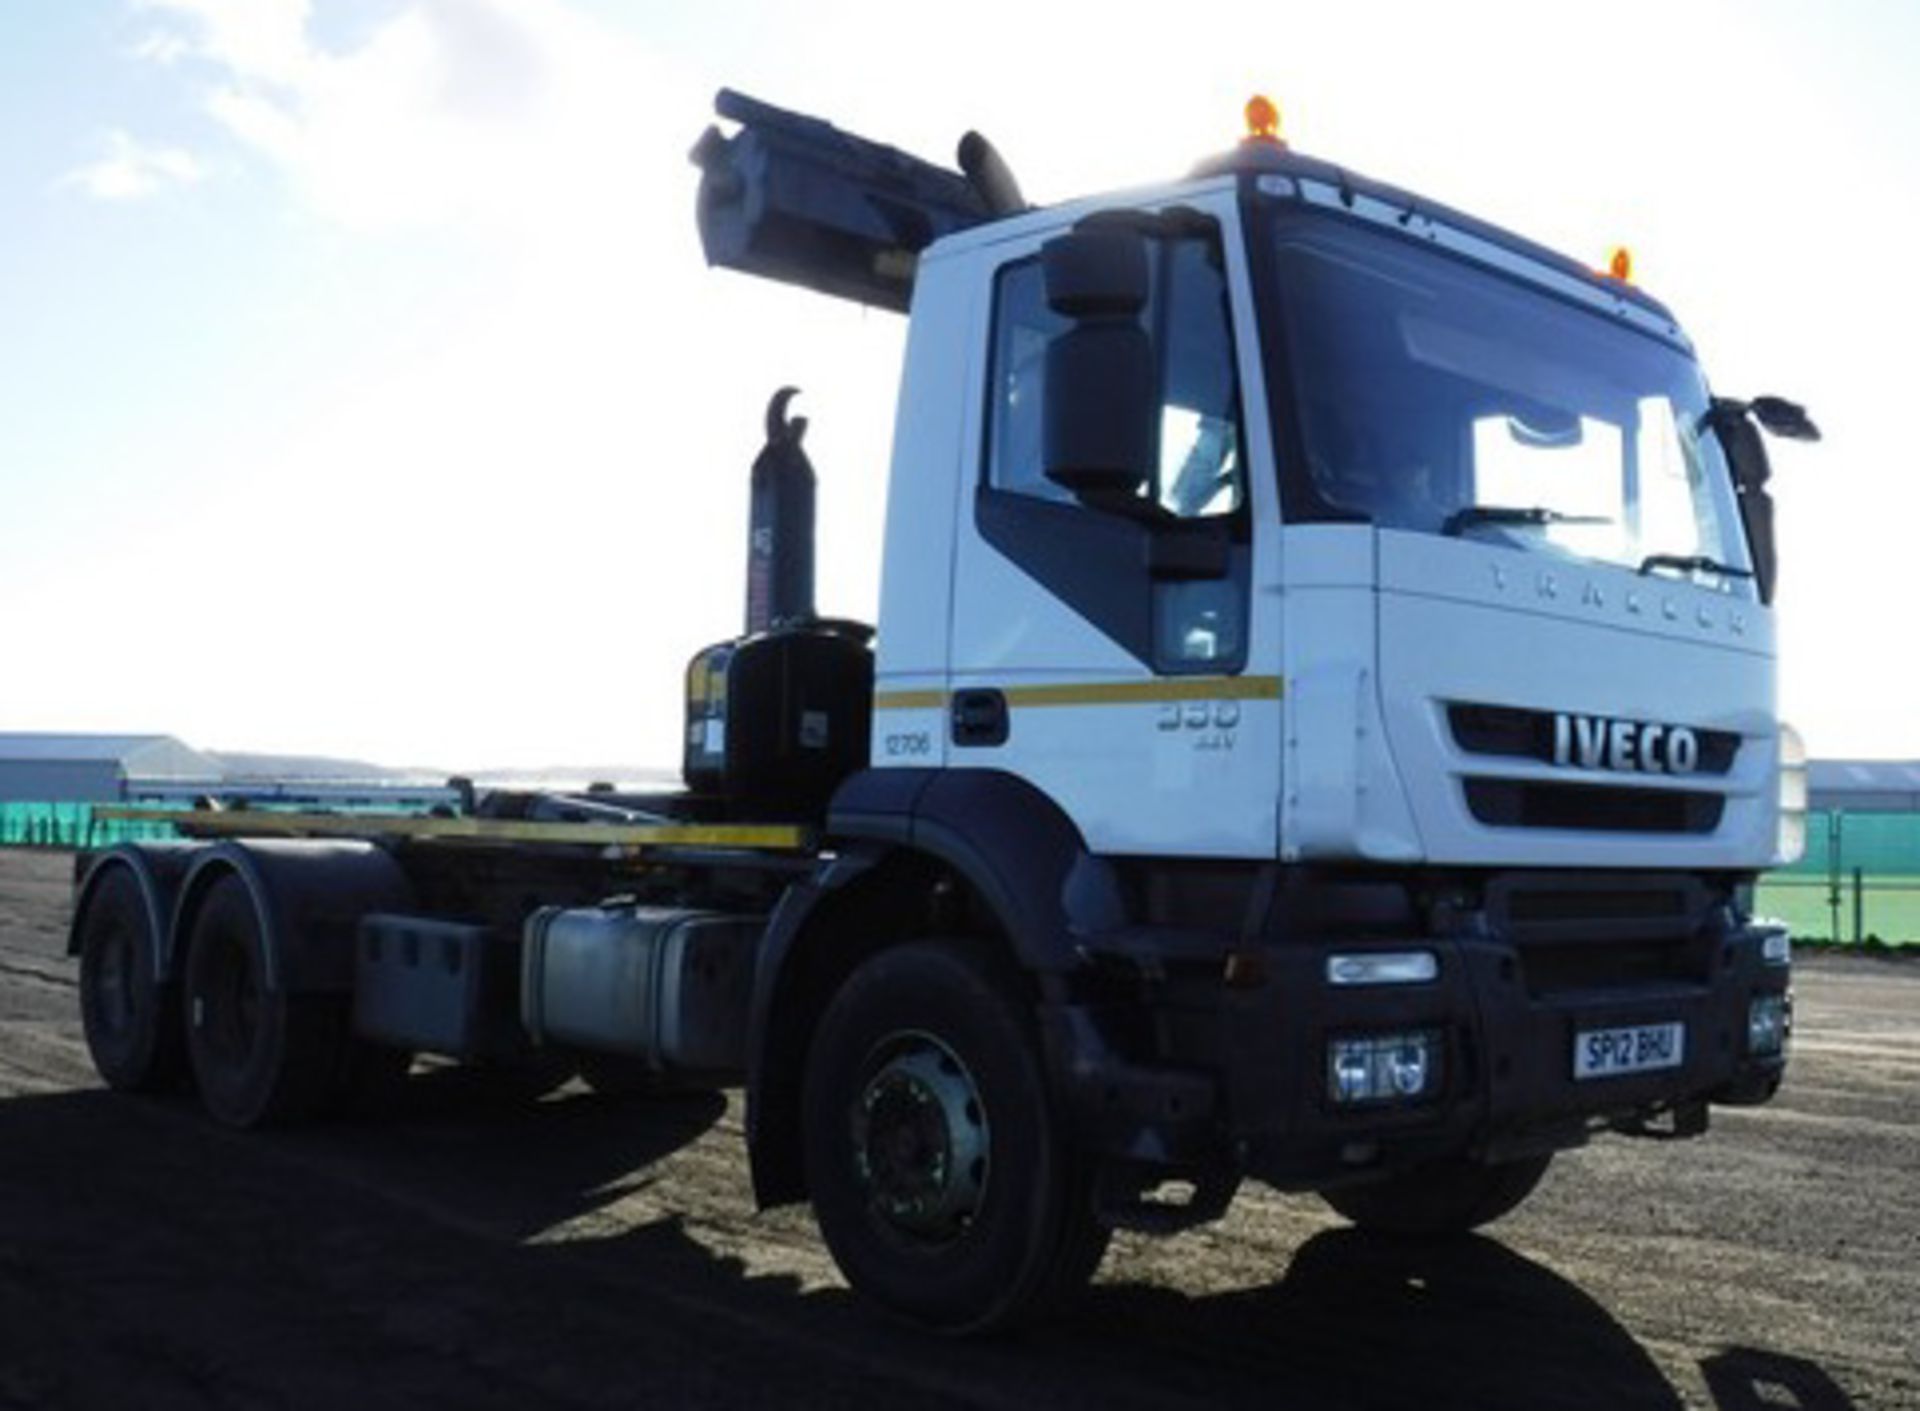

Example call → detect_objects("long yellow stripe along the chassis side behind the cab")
94 808 810 852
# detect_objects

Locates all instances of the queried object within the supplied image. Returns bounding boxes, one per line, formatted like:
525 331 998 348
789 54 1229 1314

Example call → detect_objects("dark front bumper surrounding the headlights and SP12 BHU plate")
1046 925 1789 1188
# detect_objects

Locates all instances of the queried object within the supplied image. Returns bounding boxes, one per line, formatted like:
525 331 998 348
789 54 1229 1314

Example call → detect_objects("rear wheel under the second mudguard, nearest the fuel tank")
184 877 348 1127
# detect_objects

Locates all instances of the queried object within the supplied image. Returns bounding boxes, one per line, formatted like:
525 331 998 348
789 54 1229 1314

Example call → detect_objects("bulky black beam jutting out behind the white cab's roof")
691 88 990 313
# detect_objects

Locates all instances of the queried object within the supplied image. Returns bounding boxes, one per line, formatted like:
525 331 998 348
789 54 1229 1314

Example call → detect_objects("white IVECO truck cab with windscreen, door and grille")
874 150 1780 870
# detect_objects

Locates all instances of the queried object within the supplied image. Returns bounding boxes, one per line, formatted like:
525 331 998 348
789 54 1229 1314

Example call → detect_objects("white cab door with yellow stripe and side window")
948 194 1281 856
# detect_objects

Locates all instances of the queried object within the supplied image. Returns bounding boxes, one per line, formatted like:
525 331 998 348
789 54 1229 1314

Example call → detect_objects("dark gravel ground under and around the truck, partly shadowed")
0 852 1920 1411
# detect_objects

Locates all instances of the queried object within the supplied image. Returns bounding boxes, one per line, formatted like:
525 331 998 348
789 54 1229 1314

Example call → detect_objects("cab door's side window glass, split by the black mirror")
987 240 1246 518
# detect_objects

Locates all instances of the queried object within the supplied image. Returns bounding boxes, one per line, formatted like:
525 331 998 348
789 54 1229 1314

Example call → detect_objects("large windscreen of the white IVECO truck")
1269 221 1753 597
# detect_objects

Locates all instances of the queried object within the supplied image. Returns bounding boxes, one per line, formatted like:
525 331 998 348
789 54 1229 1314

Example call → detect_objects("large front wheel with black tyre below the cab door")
804 941 1108 1332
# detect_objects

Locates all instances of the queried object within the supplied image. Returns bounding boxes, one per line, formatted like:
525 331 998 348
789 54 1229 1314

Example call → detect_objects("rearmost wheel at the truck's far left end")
79 866 186 1092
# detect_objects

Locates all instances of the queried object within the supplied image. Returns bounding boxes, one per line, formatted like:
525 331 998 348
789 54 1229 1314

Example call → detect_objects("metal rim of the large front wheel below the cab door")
852 1033 991 1244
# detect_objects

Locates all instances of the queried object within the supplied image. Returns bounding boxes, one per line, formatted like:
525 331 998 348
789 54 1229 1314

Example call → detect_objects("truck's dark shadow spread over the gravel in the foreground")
0 1075 1847 1411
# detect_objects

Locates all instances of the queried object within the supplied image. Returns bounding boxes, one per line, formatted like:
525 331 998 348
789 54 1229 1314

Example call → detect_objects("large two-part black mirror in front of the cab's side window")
1041 228 1160 505
